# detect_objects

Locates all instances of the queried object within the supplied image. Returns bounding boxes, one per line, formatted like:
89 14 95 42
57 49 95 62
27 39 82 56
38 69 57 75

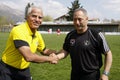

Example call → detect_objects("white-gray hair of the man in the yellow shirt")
25 3 42 19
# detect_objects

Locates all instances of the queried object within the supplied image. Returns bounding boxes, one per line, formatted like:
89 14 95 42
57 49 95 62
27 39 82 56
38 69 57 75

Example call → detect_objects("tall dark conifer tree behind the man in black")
66 0 83 21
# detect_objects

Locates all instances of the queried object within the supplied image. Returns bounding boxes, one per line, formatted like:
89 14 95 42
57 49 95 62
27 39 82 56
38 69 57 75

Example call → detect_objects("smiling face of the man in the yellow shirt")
27 8 43 30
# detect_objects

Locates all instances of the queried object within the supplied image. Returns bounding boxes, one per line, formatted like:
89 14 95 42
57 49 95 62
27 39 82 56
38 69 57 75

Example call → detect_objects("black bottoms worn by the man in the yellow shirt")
0 61 32 80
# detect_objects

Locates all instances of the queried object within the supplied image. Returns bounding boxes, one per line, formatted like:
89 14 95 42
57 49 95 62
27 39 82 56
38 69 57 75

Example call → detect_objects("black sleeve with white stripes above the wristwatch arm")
99 32 110 54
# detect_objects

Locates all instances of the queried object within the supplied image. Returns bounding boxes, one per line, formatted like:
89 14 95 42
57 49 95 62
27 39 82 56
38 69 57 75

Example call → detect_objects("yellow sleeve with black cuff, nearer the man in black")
37 33 46 52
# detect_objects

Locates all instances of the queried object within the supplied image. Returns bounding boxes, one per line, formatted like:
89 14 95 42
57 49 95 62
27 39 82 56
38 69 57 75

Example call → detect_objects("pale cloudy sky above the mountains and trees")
0 0 120 20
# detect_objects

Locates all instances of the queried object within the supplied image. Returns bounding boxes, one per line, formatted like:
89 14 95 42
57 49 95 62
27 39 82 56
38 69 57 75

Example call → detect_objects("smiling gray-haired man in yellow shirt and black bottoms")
0 4 57 80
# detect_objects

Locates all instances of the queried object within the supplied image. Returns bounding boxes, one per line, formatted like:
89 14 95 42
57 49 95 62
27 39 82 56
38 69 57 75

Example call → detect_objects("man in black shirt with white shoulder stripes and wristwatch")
50 8 112 80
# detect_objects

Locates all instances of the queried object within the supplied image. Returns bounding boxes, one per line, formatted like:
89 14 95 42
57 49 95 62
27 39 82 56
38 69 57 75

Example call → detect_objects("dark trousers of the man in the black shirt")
71 70 100 80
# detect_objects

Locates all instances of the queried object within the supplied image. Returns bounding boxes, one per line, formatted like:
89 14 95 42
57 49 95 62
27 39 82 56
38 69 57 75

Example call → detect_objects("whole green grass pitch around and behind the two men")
0 33 120 80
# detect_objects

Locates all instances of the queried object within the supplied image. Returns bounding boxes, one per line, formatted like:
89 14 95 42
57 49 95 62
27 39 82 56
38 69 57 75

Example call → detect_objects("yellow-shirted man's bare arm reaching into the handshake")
18 46 57 63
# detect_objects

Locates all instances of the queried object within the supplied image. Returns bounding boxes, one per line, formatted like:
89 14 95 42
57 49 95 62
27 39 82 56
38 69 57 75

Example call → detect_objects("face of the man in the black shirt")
73 11 88 33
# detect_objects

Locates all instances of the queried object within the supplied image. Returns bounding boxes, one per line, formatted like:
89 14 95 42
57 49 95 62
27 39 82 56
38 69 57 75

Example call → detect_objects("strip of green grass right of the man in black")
106 35 120 80
